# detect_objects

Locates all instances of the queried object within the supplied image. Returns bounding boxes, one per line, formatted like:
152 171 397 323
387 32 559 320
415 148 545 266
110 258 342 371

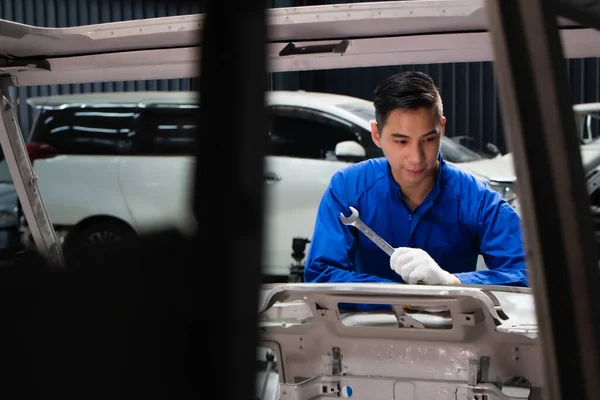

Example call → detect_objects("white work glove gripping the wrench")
390 247 460 285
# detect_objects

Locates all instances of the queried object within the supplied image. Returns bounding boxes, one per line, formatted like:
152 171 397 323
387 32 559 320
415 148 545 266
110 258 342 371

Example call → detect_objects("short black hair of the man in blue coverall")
373 71 444 129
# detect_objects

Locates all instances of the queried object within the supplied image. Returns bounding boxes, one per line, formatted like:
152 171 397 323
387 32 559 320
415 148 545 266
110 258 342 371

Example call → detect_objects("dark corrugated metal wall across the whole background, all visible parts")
0 0 600 152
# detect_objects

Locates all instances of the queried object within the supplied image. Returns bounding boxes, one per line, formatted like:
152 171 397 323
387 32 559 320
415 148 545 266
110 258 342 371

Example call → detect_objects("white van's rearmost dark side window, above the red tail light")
30 107 136 155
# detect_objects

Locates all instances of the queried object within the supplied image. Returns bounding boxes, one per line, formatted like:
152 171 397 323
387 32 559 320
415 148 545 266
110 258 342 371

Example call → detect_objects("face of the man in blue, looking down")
371 107 446 186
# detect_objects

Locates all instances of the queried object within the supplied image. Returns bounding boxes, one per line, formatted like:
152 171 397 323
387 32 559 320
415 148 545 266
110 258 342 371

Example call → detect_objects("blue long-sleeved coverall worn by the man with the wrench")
304 155 528 286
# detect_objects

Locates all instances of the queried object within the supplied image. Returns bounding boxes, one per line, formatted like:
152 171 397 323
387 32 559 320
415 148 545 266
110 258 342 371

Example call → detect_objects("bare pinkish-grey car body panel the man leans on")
258 284 542 400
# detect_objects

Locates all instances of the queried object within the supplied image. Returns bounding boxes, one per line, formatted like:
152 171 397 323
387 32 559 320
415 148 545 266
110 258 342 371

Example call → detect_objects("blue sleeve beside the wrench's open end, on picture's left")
304 172 397 283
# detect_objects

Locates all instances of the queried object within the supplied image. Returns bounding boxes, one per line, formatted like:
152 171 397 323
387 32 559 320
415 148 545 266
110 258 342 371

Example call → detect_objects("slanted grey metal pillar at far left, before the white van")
0 77 65 269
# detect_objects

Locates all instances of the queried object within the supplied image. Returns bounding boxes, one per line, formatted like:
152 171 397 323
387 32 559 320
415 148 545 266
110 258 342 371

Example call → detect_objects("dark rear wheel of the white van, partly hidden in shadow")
63 221 138 268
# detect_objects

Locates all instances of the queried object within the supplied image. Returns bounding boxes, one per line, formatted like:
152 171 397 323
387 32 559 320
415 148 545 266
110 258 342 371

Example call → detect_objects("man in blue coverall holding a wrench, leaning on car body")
305 72 528 286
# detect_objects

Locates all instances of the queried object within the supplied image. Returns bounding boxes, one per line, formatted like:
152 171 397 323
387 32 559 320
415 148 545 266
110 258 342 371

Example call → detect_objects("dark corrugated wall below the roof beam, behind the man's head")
274 58 600 153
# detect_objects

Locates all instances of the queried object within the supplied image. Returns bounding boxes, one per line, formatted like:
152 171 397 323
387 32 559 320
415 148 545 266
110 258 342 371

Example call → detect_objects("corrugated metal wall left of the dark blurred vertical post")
0 0 206 134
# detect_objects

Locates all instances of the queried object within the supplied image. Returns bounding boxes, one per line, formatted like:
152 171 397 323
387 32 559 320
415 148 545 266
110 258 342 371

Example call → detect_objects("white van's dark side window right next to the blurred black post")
138 105 199 155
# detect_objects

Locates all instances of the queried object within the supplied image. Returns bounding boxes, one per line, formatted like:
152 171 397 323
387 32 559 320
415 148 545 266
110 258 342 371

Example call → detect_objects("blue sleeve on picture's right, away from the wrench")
456 186 529 287
